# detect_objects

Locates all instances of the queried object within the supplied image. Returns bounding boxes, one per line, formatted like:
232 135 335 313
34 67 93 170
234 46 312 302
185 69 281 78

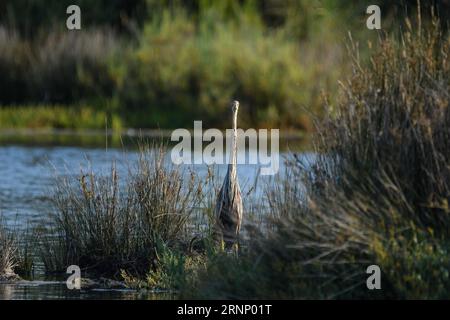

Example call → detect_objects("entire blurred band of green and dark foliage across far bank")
0 0 450 129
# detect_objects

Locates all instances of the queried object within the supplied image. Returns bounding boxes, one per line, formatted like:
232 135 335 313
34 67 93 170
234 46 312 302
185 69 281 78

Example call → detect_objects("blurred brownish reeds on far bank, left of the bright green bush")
0 26 120 104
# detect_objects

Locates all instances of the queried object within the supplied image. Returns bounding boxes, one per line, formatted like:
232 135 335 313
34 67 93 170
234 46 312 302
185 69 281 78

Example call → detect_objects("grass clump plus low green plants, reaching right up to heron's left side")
33 144 261 292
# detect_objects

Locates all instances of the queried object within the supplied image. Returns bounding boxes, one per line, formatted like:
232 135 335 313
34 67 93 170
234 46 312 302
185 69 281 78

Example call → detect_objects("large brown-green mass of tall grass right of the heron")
185 10 450 299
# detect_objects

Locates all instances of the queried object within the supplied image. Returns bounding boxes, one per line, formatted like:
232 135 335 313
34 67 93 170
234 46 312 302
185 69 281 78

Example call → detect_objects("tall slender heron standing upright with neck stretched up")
215 101 244 247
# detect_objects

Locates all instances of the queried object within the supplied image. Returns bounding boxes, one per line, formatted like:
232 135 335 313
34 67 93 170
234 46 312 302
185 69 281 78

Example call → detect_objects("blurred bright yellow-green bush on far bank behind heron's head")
118 11 308 128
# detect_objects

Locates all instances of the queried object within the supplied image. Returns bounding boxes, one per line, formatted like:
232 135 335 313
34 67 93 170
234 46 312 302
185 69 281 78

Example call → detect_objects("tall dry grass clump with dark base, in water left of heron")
41 147 206 277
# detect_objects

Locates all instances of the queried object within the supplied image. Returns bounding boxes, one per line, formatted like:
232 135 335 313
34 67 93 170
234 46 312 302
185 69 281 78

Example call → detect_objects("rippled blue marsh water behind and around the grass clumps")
0 130 310 299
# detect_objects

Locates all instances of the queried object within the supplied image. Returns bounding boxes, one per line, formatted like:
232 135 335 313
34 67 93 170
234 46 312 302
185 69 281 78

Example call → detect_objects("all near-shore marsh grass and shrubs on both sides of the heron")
0 2 450 299
